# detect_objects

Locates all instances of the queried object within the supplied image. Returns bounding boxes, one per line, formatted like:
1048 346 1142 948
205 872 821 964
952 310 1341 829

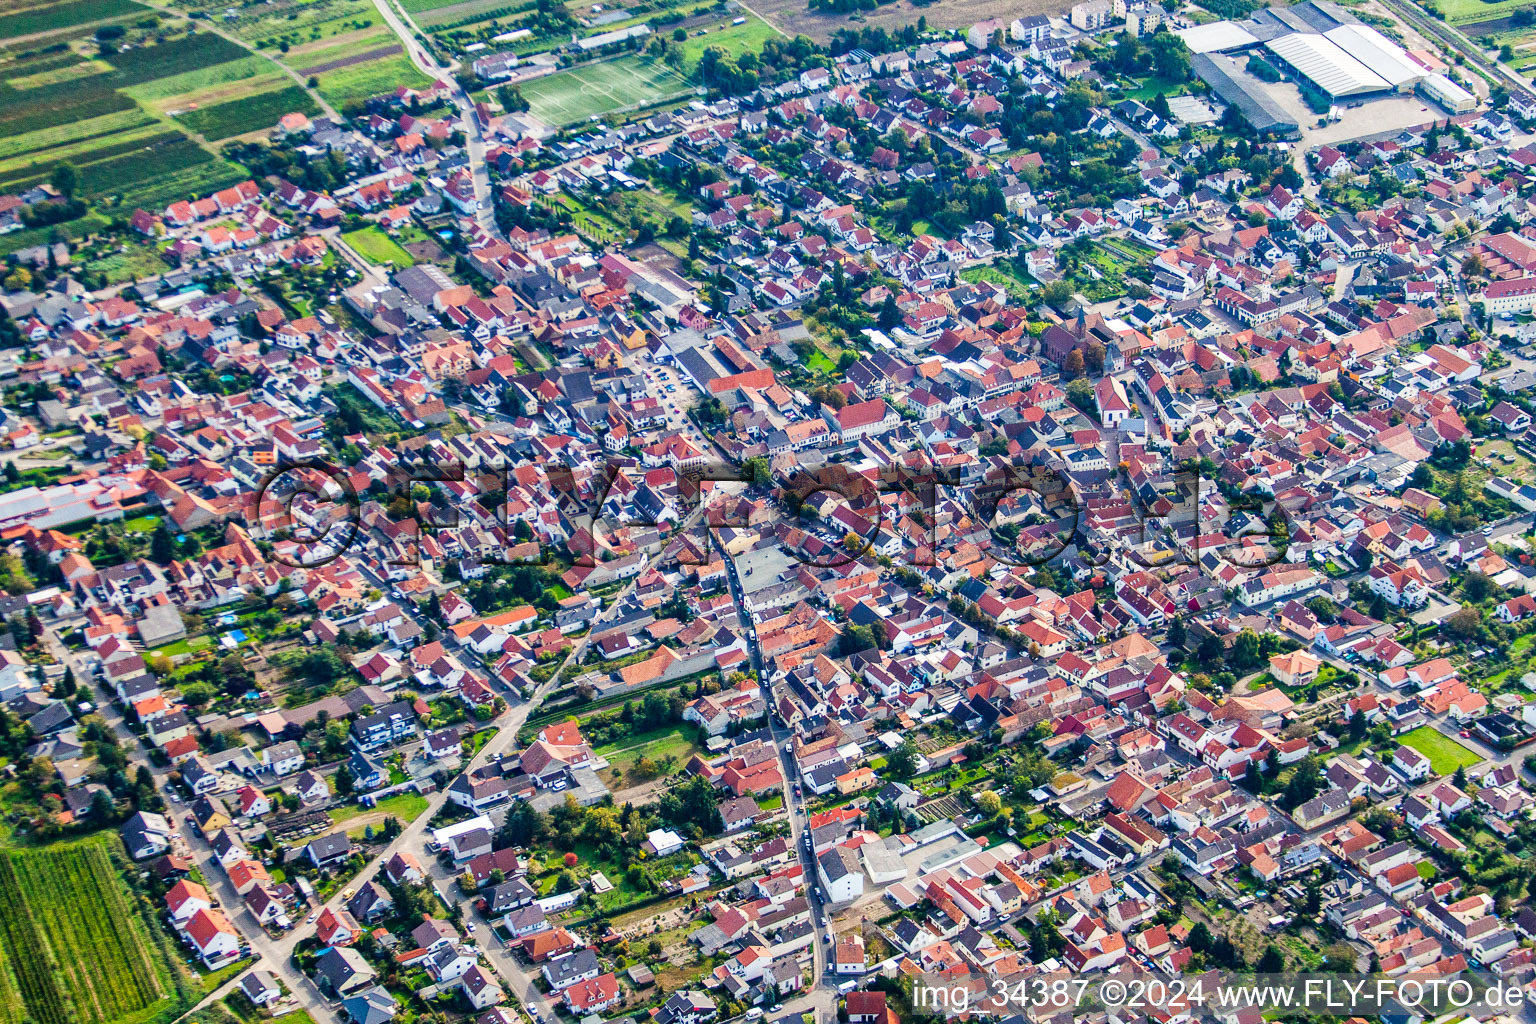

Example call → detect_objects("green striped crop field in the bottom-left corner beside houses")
0 841 175 1024
